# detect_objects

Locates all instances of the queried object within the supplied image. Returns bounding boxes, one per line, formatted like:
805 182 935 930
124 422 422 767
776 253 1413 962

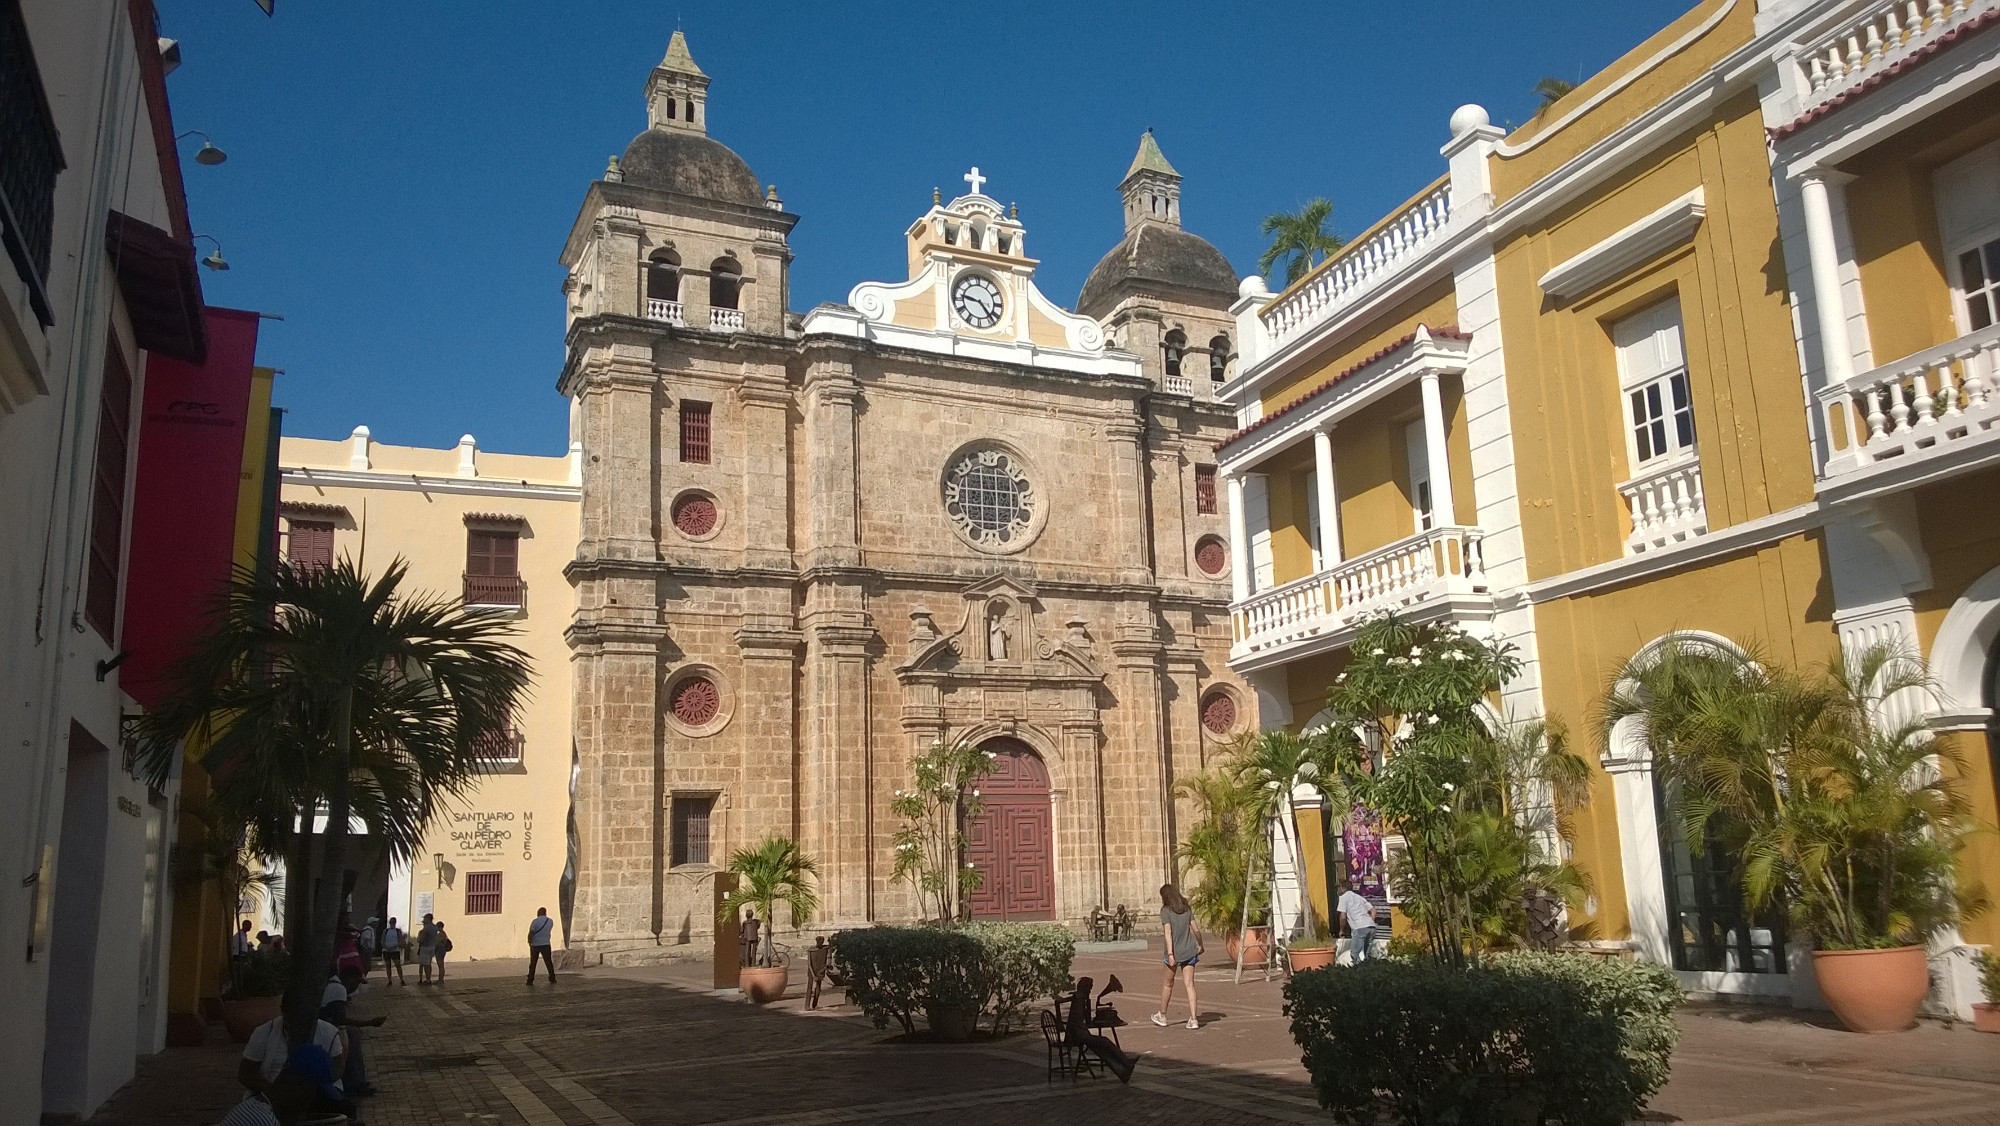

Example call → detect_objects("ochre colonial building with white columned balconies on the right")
1218 0 2000 1012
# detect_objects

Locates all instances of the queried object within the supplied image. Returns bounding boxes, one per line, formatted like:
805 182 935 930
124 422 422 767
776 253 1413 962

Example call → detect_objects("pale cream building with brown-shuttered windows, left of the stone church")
270 426 580 958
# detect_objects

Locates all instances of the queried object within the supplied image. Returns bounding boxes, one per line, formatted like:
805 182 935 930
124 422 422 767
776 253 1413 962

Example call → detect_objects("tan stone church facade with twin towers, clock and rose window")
560 32 1254 960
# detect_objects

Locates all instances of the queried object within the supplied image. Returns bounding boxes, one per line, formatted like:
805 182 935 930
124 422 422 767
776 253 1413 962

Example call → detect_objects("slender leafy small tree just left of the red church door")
890 742 998 922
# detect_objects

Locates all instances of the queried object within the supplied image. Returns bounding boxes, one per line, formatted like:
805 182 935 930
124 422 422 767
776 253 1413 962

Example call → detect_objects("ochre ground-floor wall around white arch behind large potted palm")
1534 534 1834 938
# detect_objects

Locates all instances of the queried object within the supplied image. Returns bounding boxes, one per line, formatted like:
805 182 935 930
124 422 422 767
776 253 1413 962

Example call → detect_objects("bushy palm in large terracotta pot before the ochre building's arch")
1604 642 1970 1032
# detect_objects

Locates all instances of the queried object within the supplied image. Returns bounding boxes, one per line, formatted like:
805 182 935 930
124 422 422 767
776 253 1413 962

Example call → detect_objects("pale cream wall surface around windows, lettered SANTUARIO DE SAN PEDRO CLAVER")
280 438 580 958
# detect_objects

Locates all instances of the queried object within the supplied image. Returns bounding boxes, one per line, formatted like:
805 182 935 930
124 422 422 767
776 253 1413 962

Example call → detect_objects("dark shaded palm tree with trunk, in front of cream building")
132 558 530 1044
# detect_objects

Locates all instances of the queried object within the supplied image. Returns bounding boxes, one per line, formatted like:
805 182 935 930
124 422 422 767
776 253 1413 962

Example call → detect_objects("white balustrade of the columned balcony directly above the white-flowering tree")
1234 528 1486 656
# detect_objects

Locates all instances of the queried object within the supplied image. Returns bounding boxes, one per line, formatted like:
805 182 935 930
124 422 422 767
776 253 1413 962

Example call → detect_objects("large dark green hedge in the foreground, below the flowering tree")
1284 952 1680 1126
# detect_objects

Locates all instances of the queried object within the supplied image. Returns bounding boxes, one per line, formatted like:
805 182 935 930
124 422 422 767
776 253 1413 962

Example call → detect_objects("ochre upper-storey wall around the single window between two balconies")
1496 94 1812 578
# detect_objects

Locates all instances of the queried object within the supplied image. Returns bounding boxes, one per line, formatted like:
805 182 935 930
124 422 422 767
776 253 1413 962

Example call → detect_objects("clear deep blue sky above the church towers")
160 0 1694 454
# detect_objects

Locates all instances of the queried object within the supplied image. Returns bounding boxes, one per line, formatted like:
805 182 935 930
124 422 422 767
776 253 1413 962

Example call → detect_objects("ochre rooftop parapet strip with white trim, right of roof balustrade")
1490 0 1752 205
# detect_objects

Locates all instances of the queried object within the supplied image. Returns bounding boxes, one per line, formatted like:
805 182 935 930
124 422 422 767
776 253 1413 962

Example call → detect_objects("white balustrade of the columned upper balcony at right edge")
1818 324 2000 478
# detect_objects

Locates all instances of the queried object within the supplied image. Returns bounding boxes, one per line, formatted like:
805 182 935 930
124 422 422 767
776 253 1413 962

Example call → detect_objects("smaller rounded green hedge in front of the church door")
832 922 1076 1034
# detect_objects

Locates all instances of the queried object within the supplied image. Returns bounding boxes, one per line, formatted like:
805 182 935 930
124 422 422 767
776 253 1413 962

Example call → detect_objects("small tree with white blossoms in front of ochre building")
1322 616 1590 964
